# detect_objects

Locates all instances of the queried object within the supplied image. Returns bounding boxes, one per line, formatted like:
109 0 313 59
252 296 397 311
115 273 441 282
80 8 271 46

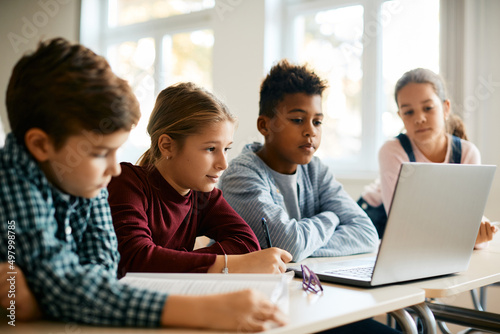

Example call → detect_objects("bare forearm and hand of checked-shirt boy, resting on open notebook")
162 290 286 333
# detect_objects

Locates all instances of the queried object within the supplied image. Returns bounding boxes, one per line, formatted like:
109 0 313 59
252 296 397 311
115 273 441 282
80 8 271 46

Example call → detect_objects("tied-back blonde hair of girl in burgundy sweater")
138 82 236 166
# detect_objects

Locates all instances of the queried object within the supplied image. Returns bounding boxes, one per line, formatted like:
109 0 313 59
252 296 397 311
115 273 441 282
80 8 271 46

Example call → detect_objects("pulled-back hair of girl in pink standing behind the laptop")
394 68 468 140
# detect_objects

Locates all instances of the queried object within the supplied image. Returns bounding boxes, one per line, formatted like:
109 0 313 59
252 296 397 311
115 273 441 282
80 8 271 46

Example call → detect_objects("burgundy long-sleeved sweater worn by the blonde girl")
108 163 260 277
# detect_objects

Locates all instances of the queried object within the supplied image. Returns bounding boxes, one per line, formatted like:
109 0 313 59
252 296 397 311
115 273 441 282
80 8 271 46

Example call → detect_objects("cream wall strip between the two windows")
213 0 265 158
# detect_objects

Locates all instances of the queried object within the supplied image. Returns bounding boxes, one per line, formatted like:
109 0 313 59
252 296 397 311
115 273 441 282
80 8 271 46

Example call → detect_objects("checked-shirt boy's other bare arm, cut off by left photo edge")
0 262 42 321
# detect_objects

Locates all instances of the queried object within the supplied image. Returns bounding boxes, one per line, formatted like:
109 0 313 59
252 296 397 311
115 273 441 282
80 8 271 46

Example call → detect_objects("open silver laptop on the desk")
292 162 496 287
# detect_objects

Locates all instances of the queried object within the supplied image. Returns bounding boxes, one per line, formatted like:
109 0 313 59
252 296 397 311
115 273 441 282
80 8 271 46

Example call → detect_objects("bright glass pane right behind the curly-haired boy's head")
290 5 363 160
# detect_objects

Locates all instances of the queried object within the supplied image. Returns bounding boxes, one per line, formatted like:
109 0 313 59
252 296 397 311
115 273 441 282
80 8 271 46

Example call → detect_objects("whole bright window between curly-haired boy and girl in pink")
285 0 439 177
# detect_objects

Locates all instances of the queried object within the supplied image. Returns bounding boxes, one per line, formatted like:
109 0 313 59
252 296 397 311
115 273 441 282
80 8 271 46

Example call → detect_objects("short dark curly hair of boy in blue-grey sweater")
259 59 327 118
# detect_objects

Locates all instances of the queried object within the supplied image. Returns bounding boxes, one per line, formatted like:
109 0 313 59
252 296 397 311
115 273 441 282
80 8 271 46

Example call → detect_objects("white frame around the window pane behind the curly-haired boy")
282 0 386 179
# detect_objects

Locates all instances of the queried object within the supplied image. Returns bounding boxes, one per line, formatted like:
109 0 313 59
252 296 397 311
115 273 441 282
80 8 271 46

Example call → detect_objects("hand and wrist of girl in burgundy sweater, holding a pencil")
227 247 292 274
